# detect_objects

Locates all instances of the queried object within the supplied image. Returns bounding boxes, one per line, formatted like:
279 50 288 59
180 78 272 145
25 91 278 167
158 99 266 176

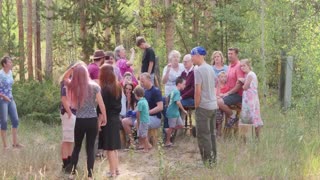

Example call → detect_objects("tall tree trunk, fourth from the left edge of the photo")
45 0 53 79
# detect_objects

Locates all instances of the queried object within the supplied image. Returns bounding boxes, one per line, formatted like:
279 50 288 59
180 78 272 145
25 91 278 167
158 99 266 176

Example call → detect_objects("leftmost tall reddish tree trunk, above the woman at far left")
16 0 25 81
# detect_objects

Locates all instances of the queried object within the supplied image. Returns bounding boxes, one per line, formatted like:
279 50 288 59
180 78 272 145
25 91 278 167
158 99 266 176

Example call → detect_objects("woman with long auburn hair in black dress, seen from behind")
97 64 122 177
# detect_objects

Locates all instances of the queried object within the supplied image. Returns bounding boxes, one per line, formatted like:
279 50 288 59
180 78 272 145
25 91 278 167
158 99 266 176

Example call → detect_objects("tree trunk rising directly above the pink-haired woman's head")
79 0 89 62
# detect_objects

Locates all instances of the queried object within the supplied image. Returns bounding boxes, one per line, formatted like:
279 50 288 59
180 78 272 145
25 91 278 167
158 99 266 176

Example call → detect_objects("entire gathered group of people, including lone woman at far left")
0 37 263 179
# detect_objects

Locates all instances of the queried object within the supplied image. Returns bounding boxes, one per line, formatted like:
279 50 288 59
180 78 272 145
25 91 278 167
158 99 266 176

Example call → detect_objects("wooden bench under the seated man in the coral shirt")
222 103 241 138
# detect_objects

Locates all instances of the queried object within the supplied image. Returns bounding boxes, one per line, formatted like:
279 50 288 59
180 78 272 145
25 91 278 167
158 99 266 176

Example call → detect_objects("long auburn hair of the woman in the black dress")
99 64 121 98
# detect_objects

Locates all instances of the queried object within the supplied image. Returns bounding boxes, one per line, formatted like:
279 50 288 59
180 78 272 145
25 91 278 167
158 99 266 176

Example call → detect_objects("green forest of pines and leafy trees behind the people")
0 0 320 178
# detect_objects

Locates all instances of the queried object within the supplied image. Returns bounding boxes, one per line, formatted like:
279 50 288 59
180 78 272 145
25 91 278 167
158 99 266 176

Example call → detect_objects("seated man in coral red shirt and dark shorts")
218 48 244 128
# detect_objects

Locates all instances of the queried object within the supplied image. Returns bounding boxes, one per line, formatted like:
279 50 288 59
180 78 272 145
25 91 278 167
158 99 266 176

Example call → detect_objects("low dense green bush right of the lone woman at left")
12 81 60 123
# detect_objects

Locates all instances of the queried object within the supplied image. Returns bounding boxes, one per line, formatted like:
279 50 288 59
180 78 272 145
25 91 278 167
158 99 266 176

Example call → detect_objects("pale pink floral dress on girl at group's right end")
240 71 263 127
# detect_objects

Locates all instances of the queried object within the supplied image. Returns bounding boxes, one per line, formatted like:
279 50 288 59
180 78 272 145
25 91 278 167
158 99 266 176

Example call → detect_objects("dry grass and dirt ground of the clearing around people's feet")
0 97 320 179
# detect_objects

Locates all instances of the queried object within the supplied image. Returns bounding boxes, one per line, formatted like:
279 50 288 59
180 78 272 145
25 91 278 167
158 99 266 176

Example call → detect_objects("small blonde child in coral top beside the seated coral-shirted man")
216 71 230 137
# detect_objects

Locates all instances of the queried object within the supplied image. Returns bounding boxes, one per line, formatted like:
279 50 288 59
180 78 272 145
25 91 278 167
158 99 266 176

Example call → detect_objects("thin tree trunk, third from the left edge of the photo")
35 0 42 82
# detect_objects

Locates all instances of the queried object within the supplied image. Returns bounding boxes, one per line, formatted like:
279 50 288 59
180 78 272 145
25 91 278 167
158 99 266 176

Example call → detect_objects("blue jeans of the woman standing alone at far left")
0 99 19 130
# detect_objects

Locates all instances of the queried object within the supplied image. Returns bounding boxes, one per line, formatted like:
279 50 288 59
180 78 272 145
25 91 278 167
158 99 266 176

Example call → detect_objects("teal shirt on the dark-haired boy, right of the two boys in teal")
167 89 180 118
